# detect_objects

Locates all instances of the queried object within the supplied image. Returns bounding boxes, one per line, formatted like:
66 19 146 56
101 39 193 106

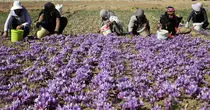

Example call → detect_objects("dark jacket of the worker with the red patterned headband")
160 12 182 35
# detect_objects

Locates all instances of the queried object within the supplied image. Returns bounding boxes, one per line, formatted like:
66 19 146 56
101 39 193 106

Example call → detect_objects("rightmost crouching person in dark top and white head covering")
185 2 209 29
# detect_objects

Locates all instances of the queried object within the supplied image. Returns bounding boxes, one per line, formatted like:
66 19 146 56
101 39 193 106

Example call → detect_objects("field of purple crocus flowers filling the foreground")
0 34 210 110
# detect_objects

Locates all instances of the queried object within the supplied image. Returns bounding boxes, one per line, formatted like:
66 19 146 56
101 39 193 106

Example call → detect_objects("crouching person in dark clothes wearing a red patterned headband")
160 6 182 38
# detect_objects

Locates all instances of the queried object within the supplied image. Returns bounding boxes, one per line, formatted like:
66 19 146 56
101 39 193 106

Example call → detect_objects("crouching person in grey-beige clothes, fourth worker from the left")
128 9 150 36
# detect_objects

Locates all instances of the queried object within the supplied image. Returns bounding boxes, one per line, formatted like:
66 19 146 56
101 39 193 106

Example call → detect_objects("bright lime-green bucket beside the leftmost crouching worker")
11 29 24 42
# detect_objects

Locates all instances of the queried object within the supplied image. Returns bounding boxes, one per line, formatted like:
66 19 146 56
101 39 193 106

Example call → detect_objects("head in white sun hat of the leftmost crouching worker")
11 0 23 16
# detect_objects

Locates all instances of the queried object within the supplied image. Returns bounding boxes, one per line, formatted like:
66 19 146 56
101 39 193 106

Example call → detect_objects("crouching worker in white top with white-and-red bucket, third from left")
100 9 123 35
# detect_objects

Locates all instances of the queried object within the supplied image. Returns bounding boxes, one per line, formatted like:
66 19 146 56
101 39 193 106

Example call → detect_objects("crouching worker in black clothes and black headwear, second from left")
36 2 67 38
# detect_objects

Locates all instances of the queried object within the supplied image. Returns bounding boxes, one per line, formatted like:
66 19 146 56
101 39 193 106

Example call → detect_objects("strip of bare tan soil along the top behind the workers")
0 0 210 12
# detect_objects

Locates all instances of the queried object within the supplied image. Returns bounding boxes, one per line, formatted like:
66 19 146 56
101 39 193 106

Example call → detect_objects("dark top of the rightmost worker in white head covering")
187 8 209 29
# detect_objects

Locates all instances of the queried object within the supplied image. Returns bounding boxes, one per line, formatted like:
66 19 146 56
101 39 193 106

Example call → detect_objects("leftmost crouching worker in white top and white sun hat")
2 1 31 37
